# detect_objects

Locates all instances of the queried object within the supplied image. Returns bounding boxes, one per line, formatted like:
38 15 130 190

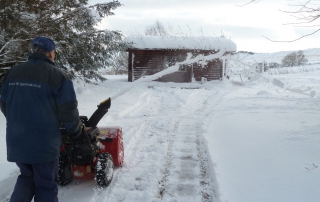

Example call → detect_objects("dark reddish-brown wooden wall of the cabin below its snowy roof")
128 49 222 83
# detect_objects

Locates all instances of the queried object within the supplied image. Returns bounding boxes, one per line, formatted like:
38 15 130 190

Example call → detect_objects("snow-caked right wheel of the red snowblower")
95 153 114 187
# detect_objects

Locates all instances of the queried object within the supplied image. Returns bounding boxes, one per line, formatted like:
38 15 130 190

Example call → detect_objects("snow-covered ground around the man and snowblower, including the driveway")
0 52 320 202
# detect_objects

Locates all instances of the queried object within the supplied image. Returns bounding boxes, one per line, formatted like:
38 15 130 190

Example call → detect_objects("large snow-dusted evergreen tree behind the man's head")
0 0 128 85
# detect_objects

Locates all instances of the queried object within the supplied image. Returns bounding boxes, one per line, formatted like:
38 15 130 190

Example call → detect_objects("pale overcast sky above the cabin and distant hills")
89 0 320 53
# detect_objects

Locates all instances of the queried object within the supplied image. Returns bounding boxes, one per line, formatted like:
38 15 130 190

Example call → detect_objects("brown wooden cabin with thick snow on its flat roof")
125 36 236 83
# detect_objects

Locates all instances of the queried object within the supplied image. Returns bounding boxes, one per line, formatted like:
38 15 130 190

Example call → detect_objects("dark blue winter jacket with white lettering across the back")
0 53 80 164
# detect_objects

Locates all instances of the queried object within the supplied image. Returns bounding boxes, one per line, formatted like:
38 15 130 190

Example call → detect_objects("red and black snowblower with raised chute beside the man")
58 98 124 187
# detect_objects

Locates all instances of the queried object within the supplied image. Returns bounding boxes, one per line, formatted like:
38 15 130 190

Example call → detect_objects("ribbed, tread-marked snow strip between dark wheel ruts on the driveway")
154 117 216 201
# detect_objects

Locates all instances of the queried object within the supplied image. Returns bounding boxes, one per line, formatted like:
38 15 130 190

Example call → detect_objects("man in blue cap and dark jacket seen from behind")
0 37 81 202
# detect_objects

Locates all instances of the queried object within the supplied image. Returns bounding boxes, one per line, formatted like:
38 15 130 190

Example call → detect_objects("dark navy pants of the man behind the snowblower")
10 160 59 202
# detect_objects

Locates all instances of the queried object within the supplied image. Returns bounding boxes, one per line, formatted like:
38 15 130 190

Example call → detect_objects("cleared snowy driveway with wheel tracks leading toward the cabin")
91 85 222 202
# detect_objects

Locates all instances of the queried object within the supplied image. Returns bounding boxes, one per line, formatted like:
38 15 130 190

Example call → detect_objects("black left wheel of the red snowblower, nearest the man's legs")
57 154 73 186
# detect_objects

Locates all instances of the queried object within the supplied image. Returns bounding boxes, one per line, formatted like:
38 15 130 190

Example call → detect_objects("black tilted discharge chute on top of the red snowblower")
86 98 111 127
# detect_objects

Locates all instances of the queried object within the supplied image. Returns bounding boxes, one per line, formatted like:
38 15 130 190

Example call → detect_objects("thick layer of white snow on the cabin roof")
124 36 237 52
